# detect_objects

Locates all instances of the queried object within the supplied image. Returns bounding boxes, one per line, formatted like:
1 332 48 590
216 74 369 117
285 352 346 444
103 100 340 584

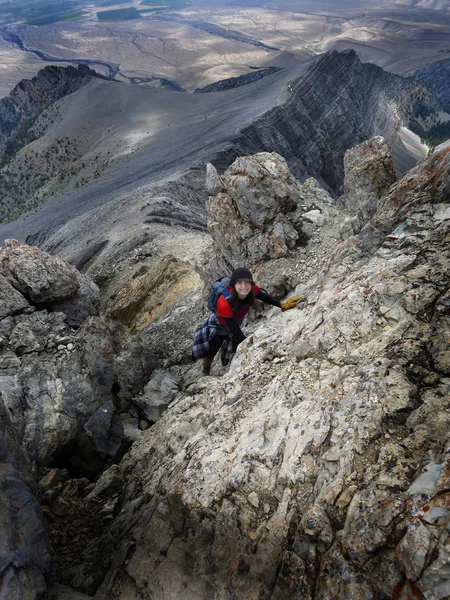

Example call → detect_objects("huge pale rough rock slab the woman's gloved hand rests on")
64 139 450 600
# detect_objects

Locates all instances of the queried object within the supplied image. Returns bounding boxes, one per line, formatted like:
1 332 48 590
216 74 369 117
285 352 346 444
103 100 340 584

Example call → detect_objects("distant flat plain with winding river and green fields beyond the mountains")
0 0 450 96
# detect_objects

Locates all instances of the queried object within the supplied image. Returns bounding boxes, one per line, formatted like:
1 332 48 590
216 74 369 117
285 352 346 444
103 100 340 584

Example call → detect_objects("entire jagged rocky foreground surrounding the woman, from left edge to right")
0 137 450 600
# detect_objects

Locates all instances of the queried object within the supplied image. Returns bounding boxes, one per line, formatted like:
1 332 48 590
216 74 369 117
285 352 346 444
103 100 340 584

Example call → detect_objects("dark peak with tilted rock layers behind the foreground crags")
212 50 440 193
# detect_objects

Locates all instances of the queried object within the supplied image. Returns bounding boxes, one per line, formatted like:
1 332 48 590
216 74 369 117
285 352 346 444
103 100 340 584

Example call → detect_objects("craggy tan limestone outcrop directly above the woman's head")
203 151 344 296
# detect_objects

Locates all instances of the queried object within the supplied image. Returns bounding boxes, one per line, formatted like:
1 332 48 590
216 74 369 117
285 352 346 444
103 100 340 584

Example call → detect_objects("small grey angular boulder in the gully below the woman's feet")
133 369 178 422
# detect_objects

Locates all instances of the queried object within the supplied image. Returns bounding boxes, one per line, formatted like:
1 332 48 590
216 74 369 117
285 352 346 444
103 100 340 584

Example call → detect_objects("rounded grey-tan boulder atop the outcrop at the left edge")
0 240 80 303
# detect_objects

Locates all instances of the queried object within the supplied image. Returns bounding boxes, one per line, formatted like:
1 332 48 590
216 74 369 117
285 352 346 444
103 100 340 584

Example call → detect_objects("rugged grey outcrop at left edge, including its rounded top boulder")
0 240 118 470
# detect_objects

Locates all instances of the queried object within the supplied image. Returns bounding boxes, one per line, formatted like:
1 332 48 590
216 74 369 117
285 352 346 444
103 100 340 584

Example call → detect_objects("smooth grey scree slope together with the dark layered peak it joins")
0 52 435 242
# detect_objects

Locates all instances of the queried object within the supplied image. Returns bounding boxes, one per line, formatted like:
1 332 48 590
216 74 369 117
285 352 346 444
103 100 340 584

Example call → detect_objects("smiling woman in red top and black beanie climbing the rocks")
192 267 301 375
